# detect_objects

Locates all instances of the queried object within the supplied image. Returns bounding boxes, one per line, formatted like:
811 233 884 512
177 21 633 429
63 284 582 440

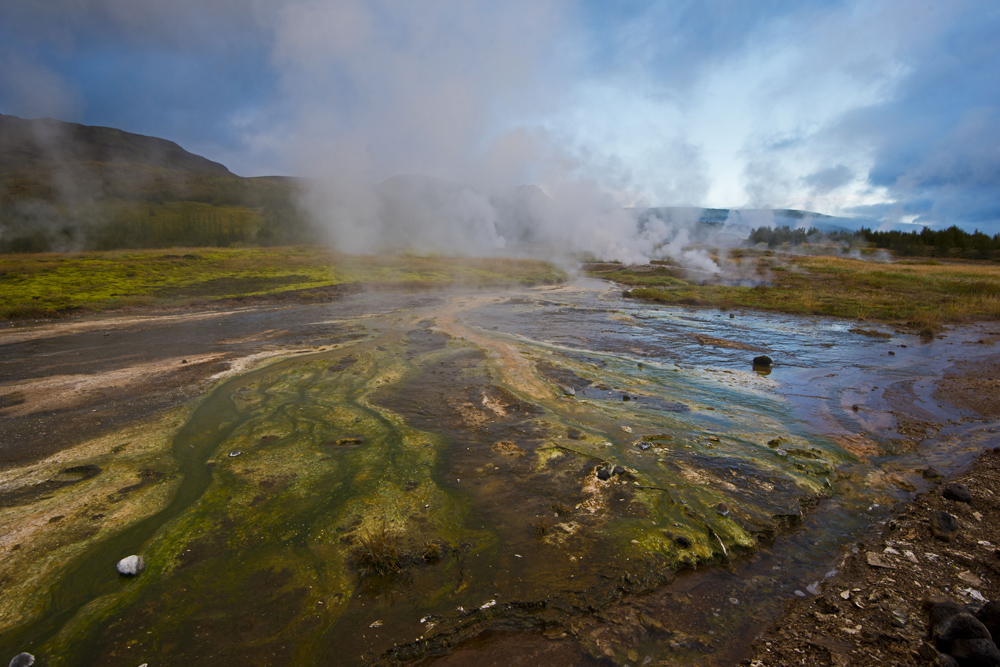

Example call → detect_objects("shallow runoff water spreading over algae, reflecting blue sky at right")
0 280 995 665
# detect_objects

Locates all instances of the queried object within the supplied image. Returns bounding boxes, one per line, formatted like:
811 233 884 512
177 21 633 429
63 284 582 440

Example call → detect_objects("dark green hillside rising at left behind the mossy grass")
0 114 317 253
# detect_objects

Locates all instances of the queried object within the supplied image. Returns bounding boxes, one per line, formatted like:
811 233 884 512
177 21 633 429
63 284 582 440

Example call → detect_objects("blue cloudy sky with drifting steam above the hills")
0 0 1000 234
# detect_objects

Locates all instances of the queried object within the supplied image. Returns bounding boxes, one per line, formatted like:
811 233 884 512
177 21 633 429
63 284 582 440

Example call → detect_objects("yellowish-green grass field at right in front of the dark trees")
594 252 1000 332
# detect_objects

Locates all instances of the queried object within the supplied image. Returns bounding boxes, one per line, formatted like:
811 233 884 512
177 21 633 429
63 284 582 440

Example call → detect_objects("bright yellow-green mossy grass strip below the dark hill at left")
0 246 565 319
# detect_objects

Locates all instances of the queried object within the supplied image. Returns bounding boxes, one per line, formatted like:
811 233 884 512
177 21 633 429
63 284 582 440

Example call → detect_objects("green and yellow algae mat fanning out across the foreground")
0 297 852 665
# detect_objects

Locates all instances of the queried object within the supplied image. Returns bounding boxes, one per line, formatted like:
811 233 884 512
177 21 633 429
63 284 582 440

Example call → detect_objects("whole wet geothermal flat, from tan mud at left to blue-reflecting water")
0 280 997 665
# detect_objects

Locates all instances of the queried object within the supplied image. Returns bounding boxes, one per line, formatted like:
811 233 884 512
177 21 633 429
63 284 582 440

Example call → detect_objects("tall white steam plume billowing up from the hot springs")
274 0 719 274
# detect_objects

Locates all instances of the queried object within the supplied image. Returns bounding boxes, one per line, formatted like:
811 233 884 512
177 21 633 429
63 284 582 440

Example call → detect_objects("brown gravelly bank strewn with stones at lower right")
741 368 1000 667
